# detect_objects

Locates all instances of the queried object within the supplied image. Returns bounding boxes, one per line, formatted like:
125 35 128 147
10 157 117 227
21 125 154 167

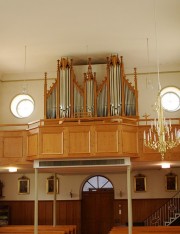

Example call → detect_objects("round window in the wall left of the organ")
11 94 34 118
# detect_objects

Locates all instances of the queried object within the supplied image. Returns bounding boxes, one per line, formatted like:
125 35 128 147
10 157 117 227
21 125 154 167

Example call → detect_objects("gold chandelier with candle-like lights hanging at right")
144 92 180 160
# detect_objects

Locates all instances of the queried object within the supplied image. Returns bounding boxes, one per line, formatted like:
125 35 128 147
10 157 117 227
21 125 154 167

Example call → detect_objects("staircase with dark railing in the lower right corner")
144 191 180 226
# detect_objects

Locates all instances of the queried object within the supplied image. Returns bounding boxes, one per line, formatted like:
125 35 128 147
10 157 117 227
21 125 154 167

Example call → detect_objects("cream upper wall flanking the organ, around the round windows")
0 65 180 123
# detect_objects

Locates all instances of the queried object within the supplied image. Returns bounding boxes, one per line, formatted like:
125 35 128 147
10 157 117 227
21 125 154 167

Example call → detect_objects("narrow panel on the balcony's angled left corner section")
27 134 38 156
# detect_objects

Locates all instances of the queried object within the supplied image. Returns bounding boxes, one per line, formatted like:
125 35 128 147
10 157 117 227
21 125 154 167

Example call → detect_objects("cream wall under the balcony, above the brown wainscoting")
0 168 180 200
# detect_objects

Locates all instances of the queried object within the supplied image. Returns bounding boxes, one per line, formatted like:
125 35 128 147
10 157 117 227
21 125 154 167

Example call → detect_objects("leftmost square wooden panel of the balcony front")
3 137 23 158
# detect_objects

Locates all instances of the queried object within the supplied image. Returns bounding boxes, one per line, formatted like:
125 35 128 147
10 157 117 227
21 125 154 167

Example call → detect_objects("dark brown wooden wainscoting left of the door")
0 200 81 229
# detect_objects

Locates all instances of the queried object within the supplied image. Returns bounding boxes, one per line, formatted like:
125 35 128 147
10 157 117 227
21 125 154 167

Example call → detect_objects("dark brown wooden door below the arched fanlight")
81 189 114 234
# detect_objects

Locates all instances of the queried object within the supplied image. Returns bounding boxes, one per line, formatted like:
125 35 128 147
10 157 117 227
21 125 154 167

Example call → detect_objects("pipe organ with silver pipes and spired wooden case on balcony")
44 55 138 119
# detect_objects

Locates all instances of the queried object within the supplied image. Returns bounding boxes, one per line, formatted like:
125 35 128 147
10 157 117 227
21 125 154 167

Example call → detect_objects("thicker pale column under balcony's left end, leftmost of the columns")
34 168 38 234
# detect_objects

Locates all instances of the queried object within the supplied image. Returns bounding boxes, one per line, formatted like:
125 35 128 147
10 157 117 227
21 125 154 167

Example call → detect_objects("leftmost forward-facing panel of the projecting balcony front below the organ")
41 132 63 154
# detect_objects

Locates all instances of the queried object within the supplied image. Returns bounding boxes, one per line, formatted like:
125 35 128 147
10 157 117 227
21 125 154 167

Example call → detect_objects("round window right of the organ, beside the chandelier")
161 87 180 112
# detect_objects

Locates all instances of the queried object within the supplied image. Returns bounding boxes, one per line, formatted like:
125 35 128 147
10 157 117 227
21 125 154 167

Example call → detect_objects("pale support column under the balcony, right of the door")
127 166 132 234
